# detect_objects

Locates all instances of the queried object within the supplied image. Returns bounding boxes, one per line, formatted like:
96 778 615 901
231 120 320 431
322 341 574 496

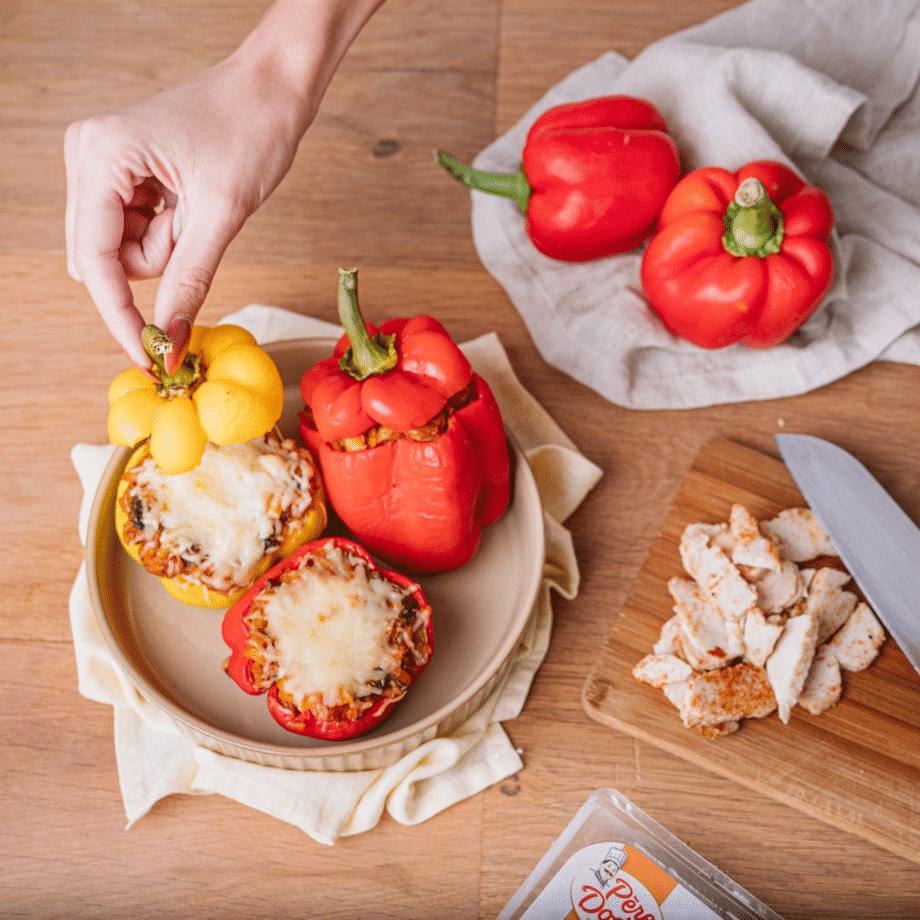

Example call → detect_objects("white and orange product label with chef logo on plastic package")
521 842 718 920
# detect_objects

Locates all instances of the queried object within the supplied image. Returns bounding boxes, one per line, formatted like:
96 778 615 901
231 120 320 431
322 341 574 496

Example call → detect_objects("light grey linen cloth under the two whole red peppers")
471 0 920 409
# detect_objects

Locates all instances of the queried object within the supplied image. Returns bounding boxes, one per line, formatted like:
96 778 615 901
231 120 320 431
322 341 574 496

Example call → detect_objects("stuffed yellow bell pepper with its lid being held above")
108 325 327 608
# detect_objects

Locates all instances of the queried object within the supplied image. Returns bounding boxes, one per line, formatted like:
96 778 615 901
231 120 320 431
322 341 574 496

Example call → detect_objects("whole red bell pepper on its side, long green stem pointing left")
435 96 681 262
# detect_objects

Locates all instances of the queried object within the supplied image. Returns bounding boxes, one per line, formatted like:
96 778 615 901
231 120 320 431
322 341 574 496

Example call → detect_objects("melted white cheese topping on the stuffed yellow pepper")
127 438 312 589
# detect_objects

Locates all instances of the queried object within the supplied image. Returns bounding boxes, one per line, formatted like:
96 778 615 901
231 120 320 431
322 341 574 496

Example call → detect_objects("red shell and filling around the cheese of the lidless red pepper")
221 537 434 741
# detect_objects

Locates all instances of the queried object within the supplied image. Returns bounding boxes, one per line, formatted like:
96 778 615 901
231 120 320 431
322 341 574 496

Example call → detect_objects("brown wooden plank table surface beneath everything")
0 0 920 920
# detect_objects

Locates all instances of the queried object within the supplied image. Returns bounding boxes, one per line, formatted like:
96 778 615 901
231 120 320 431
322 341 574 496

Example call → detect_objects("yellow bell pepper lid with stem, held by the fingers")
108 324 284 473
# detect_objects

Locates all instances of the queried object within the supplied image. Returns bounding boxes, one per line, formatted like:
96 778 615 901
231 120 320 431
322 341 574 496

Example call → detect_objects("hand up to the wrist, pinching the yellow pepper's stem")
65 56 312 370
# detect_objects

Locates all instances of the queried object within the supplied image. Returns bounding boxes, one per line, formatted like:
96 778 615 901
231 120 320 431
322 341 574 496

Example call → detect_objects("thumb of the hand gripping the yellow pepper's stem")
153 205 242 373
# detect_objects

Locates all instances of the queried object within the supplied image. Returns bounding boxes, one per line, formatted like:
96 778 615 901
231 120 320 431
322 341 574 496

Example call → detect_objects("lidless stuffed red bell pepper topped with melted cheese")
223 537 434 741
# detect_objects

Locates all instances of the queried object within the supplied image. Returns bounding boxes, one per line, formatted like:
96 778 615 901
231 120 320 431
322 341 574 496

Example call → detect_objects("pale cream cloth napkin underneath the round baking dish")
70 305 601 844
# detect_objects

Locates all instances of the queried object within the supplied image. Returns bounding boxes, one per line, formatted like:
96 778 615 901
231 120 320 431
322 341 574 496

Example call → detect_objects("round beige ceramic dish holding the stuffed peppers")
87 339 545 771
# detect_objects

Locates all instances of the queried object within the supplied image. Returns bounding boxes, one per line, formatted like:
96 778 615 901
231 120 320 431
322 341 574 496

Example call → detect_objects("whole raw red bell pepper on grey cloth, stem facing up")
641 161 834 349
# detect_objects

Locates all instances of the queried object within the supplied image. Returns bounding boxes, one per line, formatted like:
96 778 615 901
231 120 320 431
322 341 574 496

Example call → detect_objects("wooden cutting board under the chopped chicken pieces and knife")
582 440 920 863
